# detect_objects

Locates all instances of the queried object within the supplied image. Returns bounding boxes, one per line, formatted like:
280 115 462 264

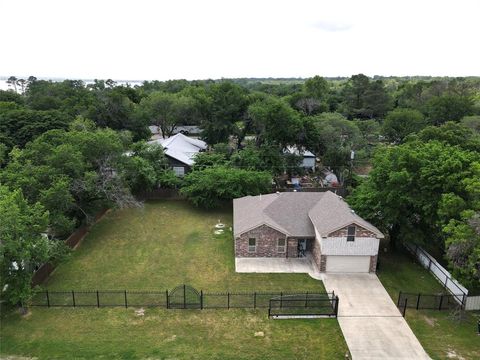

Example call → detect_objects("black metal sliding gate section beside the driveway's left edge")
268 293 339 318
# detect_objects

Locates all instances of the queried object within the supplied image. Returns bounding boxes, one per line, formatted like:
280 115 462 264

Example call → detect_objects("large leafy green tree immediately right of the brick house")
349 130 480 268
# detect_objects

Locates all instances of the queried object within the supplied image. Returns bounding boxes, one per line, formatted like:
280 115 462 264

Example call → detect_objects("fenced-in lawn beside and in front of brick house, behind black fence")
45 201 324 291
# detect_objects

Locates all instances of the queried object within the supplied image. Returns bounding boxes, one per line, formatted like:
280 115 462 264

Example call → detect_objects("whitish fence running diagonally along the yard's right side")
405 244 468 306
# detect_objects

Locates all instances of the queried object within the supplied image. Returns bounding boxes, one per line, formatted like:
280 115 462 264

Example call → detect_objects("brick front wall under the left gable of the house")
235 225 290 257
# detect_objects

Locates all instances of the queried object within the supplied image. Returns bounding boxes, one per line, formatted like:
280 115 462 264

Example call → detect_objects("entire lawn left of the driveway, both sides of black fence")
0 201 347 359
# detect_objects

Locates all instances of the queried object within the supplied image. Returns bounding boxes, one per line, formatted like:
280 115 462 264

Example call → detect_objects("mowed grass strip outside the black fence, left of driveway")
1 308 347 359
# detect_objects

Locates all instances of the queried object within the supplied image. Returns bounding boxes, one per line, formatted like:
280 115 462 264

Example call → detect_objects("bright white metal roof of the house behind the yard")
149 134 207 166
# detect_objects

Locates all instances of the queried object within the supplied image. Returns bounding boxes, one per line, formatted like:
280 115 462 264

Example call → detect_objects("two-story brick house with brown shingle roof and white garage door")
233 191 384 272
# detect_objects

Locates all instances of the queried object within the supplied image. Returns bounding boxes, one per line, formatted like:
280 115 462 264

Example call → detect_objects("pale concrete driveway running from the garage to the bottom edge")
324 273 430 360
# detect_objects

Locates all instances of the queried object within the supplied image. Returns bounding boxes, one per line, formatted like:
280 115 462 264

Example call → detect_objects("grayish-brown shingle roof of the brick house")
233 191 383 238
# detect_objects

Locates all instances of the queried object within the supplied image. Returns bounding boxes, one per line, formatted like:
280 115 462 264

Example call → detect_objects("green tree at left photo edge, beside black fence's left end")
0 185 64 310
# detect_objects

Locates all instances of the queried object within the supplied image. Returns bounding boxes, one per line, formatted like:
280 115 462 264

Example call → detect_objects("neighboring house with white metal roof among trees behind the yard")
149 134 207 176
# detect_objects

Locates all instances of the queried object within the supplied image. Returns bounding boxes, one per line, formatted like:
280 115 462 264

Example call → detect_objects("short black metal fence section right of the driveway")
397 292 465 310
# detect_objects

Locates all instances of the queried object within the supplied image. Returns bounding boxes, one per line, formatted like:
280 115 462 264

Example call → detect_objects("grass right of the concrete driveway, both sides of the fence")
378 249 480 360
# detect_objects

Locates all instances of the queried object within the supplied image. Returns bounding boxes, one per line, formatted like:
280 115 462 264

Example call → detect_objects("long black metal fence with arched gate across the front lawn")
31 285 334 309
